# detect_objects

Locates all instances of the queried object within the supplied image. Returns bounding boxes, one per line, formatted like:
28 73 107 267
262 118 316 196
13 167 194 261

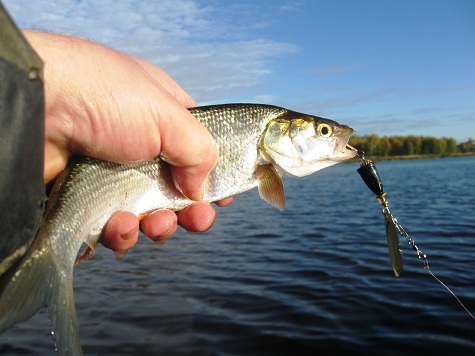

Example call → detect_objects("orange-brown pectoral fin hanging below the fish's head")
254 164 285 211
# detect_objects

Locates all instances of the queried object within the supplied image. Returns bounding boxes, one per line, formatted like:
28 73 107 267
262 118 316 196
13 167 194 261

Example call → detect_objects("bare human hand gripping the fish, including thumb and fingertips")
24 31 230 252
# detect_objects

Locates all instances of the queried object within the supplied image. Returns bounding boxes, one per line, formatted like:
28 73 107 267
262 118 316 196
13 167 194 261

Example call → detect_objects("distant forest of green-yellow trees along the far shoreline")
350 134 475 156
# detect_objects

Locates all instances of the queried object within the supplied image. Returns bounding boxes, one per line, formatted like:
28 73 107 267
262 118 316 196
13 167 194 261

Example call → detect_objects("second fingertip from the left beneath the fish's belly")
141 210 178 242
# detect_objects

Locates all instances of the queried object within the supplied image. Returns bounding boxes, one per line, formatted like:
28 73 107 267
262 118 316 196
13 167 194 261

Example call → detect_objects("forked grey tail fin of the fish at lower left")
0 235 82 355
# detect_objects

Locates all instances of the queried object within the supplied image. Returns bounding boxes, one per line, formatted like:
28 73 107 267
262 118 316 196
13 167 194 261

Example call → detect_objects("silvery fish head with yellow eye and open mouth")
259 111 356 177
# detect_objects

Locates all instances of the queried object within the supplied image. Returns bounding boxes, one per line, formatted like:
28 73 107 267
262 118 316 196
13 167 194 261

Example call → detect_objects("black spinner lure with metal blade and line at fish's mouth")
347 145 475 319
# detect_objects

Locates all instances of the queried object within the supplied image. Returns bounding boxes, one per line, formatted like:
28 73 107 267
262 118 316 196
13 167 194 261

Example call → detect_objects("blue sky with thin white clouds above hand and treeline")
3 0 475 141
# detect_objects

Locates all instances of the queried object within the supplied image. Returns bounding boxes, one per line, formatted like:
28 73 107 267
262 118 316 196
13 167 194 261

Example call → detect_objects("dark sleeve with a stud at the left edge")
0 2 45 275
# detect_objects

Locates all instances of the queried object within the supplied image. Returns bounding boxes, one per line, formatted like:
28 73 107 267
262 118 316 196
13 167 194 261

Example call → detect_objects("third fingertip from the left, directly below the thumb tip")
177 202 216 232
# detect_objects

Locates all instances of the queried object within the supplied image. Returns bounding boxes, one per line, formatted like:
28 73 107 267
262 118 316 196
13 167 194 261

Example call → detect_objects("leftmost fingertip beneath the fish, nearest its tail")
101 211 139 252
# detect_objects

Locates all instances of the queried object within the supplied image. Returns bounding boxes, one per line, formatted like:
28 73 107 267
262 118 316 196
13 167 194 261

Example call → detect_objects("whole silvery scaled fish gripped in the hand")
0 104 356 355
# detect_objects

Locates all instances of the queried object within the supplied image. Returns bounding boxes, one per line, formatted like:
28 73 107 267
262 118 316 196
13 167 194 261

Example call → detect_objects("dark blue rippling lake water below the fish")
0 157 475 355
